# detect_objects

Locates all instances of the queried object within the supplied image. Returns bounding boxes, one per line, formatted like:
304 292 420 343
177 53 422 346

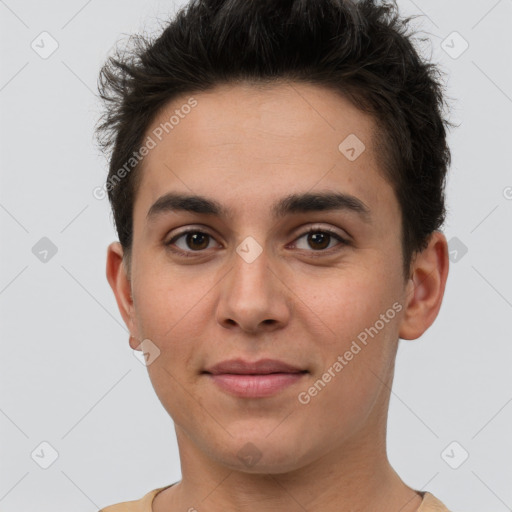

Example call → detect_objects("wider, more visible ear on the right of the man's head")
398 231 449 340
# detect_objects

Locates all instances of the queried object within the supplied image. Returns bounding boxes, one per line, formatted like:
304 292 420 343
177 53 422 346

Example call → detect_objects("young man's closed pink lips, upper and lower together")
203 359 308 398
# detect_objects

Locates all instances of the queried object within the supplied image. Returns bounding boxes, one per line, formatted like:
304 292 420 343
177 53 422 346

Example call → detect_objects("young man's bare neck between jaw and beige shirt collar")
153 418 421 512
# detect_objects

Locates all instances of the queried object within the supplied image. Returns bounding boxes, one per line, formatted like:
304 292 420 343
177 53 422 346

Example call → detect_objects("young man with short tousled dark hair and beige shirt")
98 0 450 512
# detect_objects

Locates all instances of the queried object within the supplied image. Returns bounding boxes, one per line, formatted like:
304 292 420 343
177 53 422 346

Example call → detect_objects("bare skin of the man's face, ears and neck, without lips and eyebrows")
107 83 448 512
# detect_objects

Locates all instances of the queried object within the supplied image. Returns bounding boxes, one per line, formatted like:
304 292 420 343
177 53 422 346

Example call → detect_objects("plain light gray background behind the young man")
0 0 512 512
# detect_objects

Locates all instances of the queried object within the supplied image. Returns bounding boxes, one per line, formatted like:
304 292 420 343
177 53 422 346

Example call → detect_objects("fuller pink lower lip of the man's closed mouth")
208 372 306 398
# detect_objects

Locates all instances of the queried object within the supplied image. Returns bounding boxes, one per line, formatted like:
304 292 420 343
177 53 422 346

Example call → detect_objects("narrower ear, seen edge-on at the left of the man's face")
106 242 140 350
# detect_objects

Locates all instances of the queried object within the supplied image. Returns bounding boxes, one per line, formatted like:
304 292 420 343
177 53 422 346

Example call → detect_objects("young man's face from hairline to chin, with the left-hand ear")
108 84 444 473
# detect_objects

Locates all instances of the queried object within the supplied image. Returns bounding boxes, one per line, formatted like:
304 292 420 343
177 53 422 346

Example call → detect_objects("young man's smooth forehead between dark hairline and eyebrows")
135 83 392 221
